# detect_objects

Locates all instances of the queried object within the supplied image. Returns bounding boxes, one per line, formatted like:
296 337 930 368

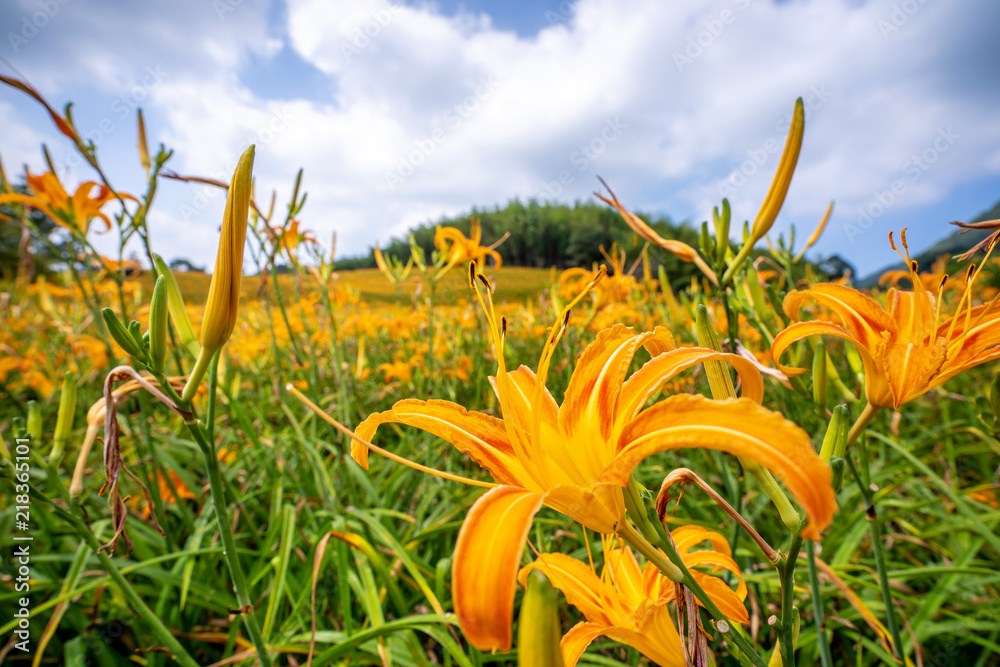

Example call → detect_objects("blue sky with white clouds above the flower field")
0 0 1000 274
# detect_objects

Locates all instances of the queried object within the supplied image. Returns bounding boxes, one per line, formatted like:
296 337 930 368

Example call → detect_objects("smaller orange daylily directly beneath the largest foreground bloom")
518 526 750 667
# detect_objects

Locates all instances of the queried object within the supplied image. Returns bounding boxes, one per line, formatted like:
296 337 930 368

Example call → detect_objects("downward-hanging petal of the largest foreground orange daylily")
451 486 543 651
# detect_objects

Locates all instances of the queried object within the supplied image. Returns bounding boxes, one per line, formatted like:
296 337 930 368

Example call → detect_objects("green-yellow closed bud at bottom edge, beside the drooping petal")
517 570 565 667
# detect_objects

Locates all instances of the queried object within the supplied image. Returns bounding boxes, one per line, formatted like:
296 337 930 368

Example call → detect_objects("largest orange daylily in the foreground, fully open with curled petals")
352 264 836 650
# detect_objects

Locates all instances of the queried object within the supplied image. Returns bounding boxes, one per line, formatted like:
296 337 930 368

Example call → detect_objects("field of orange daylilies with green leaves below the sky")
0 78 1000 667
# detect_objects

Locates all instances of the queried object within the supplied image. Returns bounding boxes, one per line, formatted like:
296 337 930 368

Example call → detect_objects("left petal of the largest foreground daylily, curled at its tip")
351 399 529 486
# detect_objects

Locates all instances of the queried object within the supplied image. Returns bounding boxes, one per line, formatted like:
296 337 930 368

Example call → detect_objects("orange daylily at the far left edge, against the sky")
0 172 135 236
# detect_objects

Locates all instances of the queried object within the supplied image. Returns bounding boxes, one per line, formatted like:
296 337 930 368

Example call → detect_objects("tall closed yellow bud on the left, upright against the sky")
182 145 254 400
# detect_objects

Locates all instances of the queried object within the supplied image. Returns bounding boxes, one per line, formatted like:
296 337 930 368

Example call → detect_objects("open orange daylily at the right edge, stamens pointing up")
771 229 1000 409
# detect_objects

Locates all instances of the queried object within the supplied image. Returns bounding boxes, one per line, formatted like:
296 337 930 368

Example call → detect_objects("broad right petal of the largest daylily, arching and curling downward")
598 395 837 540
